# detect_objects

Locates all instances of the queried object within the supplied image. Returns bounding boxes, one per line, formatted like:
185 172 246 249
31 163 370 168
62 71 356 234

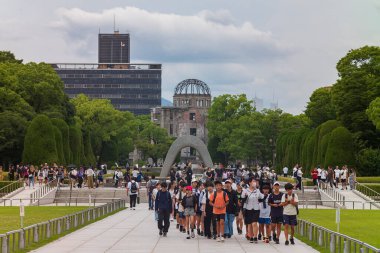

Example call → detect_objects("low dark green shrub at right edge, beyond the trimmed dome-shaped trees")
357 148 380 176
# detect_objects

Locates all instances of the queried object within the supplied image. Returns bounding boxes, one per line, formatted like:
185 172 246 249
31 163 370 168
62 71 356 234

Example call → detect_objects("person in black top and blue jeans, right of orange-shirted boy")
224 179 238 238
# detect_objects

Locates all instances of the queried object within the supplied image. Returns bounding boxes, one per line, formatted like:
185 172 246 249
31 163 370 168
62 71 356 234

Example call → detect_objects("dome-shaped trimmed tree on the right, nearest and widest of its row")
325 127 355 166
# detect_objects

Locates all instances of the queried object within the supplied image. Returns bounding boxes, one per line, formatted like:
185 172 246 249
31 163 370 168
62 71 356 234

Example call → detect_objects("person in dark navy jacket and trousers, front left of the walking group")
154 182 172 237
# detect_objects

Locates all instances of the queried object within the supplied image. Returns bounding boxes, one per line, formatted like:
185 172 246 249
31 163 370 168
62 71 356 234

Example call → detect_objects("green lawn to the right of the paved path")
299 209 380 248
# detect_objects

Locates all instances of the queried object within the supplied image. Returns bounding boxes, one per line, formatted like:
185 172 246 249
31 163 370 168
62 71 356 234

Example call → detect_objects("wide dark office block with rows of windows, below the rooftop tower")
51 63 161 115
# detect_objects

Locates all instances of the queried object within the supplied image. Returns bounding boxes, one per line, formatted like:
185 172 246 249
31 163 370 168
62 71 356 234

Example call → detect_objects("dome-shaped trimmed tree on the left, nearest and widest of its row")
23 115 58 165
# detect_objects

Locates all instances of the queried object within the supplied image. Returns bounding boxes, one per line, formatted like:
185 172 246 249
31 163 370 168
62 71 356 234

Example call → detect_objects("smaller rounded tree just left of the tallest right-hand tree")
305 87 336 126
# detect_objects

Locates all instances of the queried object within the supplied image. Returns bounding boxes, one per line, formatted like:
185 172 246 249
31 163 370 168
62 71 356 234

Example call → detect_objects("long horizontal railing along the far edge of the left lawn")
1 197 120 206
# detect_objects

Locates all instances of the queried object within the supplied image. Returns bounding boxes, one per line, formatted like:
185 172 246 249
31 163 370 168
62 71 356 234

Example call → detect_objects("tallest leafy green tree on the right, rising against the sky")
332 46 380 146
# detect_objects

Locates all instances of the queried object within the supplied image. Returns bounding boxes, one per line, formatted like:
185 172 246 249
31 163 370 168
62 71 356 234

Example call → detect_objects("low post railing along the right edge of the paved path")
296 220 380 253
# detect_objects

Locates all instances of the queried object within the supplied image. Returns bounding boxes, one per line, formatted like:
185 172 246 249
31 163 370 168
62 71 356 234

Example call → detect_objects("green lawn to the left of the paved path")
0 206 88 234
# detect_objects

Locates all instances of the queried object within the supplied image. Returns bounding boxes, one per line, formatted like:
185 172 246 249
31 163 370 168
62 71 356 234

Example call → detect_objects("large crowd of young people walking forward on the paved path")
147 165 298 245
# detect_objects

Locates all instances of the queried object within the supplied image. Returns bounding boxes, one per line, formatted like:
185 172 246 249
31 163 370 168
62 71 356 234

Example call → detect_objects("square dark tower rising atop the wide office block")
98 31 130 63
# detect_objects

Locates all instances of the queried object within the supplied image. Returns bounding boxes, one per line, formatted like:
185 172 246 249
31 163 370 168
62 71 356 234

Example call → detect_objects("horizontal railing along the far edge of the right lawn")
298 199 380 210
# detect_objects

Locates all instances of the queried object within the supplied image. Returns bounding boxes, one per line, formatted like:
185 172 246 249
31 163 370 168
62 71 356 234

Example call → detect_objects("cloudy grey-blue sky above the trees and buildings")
0 0 380 114
